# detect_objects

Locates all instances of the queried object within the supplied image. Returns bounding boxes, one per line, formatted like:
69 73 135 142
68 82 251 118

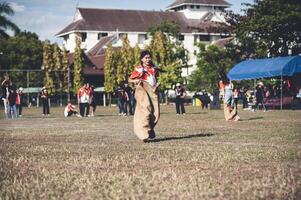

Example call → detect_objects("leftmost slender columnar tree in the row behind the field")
43 40 55 95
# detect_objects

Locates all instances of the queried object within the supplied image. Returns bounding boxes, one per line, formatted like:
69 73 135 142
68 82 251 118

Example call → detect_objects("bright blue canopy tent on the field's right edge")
227 56 301 109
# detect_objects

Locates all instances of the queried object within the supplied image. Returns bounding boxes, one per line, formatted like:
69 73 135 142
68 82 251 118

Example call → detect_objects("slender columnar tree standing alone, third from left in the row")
73 37 84 94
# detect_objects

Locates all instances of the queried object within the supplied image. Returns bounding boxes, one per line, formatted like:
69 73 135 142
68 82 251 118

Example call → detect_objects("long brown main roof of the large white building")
57 7 226 36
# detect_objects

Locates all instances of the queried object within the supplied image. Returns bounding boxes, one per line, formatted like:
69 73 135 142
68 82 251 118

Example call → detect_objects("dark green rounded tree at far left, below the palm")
0 32 44 87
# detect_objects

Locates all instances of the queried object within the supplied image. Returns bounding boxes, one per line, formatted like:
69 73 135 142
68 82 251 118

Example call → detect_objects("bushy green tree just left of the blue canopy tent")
188 43 234 92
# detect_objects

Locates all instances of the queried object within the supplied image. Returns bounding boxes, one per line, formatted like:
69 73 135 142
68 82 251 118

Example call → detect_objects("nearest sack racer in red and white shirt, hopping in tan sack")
128 51 160 142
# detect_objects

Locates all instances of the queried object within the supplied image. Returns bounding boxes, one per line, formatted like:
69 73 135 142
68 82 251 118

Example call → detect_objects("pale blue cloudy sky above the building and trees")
5 0 253 43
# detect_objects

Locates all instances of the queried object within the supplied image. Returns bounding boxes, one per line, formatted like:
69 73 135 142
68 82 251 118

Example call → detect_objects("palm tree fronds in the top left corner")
0 2 20 38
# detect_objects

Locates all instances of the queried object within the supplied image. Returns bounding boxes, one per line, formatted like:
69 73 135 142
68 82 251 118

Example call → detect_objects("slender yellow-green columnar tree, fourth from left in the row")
104 45 117 93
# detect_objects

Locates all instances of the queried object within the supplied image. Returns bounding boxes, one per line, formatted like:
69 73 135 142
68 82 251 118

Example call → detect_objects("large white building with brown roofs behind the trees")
57 0 230 82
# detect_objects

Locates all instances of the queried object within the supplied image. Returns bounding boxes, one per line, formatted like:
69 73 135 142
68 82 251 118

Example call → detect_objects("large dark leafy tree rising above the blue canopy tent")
228 0 301 58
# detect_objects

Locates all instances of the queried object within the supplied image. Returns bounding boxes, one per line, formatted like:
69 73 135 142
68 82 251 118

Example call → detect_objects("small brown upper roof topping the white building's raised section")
167 0 231 9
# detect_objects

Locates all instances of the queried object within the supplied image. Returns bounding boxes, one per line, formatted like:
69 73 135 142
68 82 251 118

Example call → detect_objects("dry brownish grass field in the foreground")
0 106 301 199
